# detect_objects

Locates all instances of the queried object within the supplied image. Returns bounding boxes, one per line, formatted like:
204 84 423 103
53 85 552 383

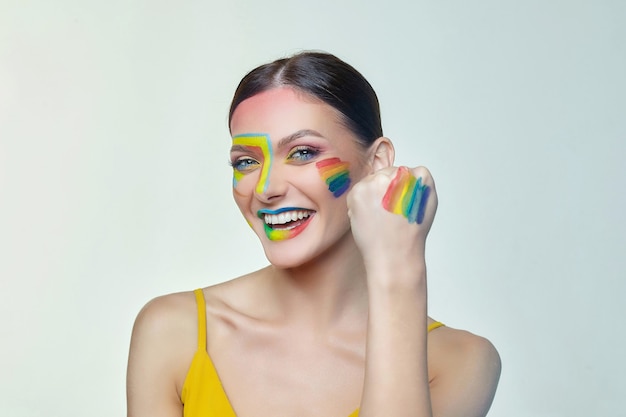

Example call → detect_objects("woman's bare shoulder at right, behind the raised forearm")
428 327 501 417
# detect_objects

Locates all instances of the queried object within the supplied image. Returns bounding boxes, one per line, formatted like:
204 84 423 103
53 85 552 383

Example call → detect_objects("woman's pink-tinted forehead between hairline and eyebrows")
230 87 347 139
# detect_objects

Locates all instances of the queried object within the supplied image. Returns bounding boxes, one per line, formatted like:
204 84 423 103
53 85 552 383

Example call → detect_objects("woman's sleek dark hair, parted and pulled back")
228 52 383 147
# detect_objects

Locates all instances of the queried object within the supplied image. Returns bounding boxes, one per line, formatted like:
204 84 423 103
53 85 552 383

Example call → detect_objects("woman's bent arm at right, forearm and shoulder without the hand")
360 256 501 417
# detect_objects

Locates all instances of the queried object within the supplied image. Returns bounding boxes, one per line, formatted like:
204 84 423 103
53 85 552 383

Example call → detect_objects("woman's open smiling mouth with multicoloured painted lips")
257 207 313 241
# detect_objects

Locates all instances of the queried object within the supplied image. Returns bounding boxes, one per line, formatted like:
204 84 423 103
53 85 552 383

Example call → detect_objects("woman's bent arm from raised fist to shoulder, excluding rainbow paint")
348 168 499 417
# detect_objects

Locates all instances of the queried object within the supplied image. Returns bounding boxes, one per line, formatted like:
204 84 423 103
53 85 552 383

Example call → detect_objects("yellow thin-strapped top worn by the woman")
180 289 443 417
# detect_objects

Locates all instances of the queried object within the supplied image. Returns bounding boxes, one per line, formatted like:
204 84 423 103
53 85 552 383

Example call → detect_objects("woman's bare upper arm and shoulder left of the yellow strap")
126 294 196 417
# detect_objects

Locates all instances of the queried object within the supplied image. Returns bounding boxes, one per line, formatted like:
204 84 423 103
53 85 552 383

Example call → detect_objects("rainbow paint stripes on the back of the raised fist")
383 167 430 224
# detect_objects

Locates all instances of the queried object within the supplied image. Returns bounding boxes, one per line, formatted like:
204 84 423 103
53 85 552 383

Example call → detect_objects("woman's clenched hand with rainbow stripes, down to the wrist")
348 167 437 276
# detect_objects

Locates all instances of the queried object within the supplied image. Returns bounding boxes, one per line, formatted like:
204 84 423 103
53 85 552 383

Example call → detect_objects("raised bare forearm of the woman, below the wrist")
359 262 432 417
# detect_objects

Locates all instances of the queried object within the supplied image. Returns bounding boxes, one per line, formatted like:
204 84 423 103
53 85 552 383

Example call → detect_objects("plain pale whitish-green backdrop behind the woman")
0 0 626 417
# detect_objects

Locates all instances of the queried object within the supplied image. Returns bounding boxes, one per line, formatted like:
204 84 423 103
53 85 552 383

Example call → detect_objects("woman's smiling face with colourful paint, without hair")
230 87 368 267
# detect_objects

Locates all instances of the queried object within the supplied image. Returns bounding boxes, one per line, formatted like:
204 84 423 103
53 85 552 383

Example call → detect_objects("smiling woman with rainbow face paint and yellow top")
127 52 500 417
